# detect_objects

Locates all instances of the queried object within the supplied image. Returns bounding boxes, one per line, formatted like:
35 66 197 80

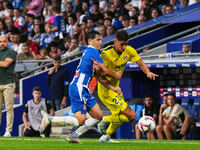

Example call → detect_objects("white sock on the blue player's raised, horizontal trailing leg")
49 116 79 126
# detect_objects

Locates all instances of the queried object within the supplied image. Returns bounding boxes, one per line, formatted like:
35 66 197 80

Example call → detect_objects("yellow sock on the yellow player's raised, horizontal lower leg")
104 114 129 123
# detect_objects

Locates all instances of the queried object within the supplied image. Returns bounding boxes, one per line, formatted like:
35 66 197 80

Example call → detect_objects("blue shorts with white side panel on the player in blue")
69 84 97 114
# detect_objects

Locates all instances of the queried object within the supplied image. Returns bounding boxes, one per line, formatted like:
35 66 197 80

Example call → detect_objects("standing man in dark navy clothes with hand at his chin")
48 55 69 110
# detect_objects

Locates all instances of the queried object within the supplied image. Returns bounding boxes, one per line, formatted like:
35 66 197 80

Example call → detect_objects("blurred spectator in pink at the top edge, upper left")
25 0 42 16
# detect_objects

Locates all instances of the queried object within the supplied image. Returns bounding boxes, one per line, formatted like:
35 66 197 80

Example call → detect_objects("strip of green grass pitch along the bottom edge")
0 137 200 150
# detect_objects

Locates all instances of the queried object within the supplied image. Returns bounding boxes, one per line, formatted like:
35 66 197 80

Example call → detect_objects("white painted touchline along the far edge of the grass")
0 137 200 145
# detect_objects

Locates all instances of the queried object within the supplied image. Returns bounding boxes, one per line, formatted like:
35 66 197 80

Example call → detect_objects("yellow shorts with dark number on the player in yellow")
98 90 128 114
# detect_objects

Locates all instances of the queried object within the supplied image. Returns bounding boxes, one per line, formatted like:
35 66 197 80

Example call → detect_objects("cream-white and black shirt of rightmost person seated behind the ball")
162 104 190 127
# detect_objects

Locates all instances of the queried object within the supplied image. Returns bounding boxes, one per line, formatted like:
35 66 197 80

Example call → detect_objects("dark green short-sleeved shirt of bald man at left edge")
0 48 17 85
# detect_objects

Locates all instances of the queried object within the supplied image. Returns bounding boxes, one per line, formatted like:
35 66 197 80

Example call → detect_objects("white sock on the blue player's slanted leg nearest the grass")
72 118 99 137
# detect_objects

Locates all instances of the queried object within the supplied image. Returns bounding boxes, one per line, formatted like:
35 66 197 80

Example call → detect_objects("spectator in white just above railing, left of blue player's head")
62 38 81 57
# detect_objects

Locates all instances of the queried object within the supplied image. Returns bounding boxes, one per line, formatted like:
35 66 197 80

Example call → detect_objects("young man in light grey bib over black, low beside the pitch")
22 87 55 137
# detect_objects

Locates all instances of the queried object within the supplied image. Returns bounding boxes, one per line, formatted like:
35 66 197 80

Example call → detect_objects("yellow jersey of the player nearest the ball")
98 45 141 97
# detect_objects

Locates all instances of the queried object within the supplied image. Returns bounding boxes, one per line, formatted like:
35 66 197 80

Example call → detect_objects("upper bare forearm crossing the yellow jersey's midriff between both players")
91 58 122 80
